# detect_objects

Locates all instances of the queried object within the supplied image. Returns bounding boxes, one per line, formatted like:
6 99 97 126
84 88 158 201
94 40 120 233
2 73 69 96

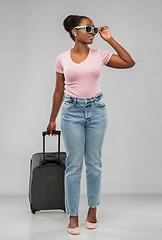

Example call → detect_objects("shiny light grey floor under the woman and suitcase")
0 194 162 240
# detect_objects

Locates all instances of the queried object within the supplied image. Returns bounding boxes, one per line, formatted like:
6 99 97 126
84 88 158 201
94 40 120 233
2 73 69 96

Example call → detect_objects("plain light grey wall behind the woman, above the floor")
0 0 162 194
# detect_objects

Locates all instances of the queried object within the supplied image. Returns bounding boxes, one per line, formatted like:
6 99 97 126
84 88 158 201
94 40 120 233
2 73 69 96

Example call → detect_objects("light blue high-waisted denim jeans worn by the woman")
61 93 108 216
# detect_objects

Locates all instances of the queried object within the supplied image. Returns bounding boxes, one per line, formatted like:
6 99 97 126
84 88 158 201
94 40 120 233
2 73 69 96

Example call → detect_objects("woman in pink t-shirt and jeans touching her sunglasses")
47 15 135 234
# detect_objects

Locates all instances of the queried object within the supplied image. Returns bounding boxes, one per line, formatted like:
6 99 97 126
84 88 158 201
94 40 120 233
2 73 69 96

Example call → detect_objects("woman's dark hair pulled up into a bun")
63 15 88 41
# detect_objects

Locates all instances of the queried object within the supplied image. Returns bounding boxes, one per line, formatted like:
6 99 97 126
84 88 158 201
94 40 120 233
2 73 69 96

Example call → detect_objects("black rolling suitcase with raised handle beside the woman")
28 131 66 214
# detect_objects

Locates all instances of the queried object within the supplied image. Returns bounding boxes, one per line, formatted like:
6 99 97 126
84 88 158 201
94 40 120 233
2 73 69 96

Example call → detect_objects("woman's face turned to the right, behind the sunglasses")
72 18 95 44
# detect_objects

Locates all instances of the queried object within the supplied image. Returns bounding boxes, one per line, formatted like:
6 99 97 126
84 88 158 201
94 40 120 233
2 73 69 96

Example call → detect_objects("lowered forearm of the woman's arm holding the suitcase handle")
50 91 64 122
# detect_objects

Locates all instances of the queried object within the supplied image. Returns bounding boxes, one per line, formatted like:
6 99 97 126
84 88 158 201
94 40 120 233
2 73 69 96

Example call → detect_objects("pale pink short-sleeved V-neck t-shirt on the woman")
55 48 112 98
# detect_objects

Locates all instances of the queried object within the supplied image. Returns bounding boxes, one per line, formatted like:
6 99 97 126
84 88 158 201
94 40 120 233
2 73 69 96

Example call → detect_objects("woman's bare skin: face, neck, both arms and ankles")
47 18 135 231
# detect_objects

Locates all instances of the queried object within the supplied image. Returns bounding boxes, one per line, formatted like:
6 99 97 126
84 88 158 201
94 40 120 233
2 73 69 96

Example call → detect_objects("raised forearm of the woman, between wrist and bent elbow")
107 37 134 63
